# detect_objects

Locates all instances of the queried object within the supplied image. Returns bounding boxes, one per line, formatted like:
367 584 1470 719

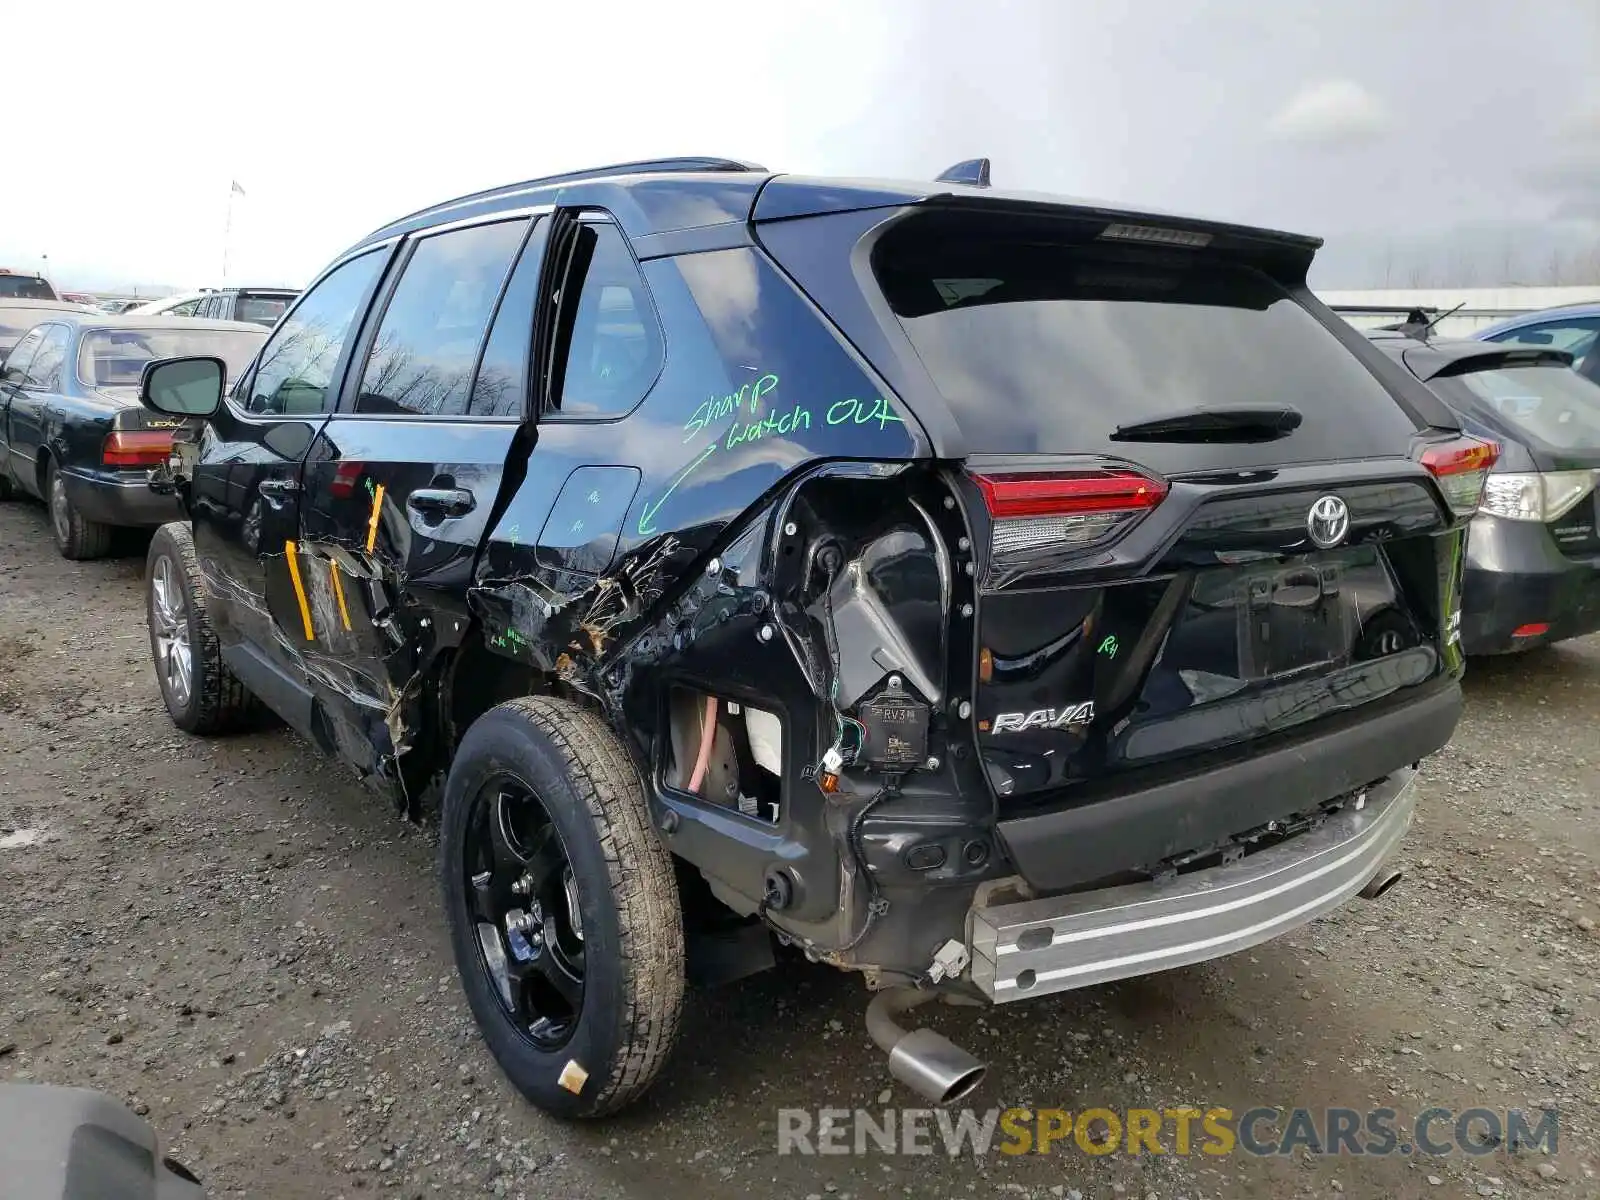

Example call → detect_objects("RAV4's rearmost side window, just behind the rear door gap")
552 222 662 416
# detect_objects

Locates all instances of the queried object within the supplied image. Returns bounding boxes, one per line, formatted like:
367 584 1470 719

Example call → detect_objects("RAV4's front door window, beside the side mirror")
245 251 386 416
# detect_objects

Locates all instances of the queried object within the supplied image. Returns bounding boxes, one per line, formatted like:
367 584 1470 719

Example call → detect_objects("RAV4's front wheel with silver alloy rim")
144 522 259 736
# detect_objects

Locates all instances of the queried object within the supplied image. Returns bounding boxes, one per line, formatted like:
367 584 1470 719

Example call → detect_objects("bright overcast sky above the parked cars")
0 0 1600 294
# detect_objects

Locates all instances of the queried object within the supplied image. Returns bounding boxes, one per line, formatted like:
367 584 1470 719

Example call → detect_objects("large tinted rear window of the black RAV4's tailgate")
874 221 1414 470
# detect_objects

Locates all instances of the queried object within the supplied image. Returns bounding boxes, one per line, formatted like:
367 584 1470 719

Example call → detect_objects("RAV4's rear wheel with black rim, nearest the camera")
438 696 683 1117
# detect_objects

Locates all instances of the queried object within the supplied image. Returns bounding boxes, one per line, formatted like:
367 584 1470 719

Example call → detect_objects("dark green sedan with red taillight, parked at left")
0 310 267 558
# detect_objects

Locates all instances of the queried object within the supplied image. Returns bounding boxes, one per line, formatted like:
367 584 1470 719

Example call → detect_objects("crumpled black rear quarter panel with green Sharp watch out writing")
469 246 928 704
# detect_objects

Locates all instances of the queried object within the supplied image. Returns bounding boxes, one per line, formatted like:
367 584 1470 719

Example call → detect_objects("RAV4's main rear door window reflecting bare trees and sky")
355 221 528 416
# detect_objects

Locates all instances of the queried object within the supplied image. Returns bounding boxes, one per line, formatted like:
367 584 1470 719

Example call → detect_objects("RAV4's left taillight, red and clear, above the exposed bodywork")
973 467 1166 568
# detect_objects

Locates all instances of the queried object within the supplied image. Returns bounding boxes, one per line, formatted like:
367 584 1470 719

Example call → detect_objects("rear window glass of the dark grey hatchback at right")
1434 363 1600 450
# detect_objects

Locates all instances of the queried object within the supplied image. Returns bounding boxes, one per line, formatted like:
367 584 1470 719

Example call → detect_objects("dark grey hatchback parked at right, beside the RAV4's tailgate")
1370 334 1600 654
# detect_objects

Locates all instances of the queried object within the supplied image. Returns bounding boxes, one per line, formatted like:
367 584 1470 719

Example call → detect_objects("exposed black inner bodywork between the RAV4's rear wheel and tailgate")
605 464 1003 974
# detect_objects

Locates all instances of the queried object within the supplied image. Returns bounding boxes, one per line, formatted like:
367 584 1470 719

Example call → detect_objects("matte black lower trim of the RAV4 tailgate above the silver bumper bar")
998 678 1461 893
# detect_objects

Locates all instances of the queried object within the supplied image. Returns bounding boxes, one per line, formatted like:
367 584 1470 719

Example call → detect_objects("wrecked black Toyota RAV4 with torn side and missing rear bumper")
142 160 1494 1115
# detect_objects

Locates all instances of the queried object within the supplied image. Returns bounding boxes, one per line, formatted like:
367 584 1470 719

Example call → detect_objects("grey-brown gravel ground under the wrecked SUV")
0 492 1600 1200
